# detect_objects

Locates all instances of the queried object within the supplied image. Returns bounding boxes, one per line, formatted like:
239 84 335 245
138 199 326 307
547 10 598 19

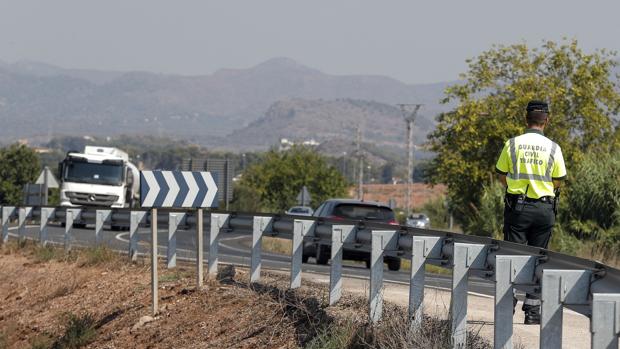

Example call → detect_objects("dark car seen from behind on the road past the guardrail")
303 199 400 270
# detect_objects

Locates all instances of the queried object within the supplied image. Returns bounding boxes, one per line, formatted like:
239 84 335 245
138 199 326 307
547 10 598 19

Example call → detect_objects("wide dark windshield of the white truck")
64 161 123 185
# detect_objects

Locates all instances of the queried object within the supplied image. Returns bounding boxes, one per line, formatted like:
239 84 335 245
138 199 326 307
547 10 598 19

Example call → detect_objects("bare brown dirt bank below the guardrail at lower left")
0 242 365 348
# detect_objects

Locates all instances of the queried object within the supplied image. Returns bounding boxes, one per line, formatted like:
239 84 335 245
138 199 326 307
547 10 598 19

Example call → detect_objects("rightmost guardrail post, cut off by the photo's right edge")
590 293 620 349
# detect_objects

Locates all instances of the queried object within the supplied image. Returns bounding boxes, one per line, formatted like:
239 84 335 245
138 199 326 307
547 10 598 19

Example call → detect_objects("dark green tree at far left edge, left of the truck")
0 144 41 205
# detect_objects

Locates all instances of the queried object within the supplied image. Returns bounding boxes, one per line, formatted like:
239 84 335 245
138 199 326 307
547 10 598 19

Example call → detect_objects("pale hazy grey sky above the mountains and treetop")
0 0 620 83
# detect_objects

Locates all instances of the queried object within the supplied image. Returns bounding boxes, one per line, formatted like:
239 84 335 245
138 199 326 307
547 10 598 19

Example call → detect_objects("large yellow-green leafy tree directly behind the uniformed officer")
428 40 620 231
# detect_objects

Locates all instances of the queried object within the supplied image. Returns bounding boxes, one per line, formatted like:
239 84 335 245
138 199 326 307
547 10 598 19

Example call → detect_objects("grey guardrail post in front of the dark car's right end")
368 230 398 323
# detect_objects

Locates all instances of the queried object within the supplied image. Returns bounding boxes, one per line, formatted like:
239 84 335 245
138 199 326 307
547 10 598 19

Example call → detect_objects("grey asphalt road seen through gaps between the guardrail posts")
15 224 495 296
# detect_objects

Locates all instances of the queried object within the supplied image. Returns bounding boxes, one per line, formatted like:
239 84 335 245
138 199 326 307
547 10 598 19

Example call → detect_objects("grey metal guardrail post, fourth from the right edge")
450 242 487 349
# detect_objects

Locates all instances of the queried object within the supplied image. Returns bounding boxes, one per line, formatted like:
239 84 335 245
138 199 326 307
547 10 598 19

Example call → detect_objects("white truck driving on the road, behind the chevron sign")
58 146 140 207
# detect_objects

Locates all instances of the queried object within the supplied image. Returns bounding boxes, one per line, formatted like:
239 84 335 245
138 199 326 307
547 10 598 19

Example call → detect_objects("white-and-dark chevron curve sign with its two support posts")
140 171 217 315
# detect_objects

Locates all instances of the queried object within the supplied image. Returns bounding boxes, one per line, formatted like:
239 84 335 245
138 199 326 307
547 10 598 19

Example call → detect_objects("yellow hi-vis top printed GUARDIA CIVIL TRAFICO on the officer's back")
495 129 566 199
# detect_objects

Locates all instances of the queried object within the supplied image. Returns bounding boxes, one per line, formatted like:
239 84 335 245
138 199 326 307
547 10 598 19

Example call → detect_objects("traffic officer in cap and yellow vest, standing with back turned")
495 101 566 324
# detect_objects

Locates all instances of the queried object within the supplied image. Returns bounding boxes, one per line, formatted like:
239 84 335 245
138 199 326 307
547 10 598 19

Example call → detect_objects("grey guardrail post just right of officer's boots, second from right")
540 269 592 349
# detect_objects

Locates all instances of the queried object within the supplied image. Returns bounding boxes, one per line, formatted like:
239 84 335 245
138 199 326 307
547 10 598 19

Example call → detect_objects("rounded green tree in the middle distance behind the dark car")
239 146 347 211
